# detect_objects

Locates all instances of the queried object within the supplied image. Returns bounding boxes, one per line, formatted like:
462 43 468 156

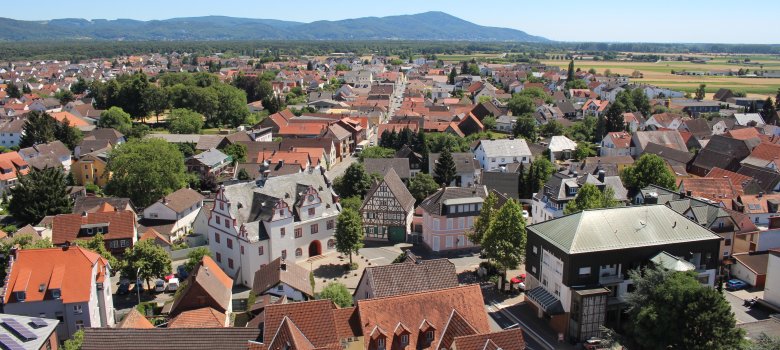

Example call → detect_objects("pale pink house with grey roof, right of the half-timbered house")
420 185 507 252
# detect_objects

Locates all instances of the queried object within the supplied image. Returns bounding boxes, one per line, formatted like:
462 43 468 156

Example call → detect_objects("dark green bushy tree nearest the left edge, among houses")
8 168 73 225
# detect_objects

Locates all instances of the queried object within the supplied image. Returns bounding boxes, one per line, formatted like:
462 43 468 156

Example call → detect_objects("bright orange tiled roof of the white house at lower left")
3 246 108 303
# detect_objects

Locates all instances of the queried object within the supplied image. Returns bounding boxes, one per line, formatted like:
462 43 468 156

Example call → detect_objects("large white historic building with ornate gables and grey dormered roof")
208 171 341 286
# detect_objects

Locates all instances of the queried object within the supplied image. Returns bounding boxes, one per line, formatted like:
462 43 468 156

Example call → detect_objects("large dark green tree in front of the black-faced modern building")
626 267 744 350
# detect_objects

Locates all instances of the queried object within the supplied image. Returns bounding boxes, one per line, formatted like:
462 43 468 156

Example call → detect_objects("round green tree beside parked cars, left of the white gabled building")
122 239 171 289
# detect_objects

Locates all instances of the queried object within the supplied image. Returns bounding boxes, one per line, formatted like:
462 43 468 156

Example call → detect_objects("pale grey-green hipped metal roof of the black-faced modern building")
528 205 720 254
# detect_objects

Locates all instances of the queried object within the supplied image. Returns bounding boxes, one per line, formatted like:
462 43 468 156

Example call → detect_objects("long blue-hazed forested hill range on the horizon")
0 12 549 42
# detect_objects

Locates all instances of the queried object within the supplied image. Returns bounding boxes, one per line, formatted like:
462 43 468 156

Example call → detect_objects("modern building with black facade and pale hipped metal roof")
525 205 721 341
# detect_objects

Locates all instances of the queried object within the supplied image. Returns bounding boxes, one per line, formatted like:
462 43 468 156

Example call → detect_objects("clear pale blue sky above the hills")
12 0 780 44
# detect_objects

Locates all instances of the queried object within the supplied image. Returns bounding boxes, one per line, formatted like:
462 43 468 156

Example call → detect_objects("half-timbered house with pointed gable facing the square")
360 168 414 242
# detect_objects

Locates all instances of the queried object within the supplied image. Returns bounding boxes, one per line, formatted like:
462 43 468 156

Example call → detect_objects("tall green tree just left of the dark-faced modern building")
482 199 526 290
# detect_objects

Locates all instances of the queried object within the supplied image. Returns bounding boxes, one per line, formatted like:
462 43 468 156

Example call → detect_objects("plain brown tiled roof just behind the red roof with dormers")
360 259 458 298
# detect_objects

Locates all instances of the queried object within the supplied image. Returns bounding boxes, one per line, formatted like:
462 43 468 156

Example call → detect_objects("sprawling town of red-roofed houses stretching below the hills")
0 52 780 350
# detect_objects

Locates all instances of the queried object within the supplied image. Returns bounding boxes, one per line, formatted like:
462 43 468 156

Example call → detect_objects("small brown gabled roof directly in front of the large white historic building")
252 258 314 298
